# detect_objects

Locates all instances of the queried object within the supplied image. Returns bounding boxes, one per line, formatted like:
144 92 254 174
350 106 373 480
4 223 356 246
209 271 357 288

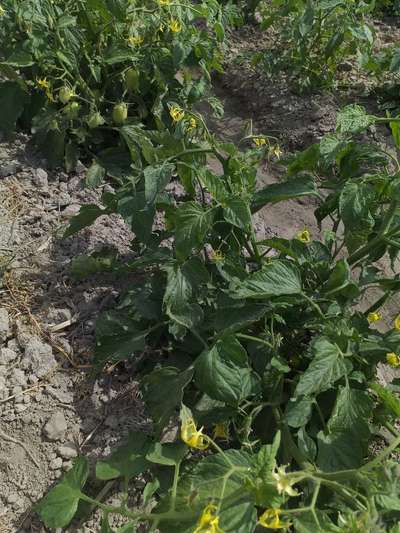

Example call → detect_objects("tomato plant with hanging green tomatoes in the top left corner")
0 0 237 166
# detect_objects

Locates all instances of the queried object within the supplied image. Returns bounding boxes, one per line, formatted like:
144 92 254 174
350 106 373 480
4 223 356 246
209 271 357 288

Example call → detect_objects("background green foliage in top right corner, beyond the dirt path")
253 0 400 91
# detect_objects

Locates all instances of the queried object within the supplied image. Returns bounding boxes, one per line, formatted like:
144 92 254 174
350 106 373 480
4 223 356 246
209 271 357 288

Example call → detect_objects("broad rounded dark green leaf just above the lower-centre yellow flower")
195 335 259 405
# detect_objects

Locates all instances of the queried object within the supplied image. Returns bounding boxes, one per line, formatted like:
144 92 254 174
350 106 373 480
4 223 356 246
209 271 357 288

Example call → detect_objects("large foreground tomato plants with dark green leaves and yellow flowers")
34 98 400 533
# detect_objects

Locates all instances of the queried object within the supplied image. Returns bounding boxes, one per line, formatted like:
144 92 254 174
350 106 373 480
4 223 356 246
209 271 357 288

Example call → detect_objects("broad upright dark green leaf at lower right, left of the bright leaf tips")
317 387 373 472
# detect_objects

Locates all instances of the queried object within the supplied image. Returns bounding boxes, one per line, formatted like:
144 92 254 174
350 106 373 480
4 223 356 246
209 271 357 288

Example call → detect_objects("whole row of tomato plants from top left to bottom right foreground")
0 0 400 533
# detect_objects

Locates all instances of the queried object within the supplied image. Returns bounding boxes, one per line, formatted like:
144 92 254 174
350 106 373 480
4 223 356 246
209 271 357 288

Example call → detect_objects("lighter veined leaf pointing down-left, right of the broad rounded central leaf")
295 337 349 397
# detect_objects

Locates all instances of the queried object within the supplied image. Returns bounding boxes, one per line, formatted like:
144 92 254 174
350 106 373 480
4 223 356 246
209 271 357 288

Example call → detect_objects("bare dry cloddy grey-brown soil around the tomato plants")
0 21 400 533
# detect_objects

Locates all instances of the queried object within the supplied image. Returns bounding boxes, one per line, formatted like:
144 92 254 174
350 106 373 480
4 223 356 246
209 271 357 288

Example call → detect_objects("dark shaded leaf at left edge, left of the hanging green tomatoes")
0 81 29 134
